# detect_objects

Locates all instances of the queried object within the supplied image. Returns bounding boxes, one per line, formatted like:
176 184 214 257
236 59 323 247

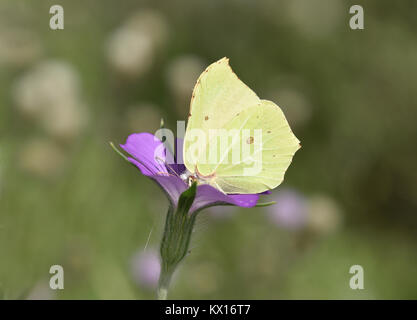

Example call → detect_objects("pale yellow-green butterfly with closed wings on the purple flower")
182 58 301 194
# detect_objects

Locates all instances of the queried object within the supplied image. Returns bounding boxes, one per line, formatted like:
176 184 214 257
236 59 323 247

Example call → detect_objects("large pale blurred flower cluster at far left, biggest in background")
13 60 86 138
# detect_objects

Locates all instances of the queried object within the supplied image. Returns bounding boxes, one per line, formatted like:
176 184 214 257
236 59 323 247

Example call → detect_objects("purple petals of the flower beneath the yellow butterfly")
120 132 259 214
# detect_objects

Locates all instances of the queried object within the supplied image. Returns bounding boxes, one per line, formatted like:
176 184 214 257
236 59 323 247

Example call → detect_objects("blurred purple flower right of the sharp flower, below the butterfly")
268 189 308 230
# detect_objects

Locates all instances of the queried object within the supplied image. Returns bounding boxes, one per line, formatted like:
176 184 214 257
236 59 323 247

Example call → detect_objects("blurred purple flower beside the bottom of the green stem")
131 249 161 289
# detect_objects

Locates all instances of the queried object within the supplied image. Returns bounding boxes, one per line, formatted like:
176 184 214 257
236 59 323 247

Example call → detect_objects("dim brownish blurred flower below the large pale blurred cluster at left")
18 139 66 178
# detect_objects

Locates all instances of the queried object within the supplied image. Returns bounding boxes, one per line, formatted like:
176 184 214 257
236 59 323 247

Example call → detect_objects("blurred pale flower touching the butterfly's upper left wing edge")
167 55 205 116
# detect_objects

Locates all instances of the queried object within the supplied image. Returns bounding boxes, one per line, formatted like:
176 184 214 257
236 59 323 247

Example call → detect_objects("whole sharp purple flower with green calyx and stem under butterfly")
111 132 270 299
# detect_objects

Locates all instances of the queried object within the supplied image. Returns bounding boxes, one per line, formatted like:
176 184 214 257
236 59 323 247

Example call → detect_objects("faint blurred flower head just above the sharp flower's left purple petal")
125 102 162 133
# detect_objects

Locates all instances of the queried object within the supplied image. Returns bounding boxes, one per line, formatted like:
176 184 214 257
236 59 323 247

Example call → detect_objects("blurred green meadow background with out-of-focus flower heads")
0 0 417 299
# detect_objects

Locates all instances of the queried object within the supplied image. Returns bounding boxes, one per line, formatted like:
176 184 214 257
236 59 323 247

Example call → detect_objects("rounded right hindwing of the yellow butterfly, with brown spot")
210 100 300 193
